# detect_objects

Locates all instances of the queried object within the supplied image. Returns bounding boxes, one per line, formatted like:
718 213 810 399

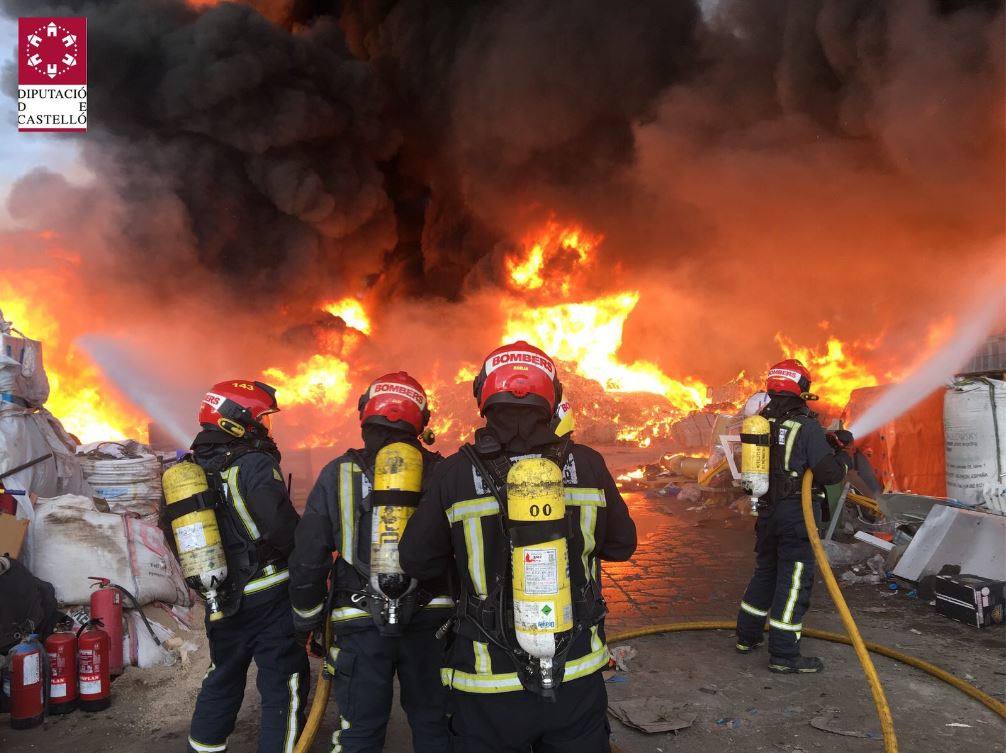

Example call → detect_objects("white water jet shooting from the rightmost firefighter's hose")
849 295 1002 439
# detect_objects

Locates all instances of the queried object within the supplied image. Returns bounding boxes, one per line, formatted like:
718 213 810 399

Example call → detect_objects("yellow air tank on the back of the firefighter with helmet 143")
162 460 227 622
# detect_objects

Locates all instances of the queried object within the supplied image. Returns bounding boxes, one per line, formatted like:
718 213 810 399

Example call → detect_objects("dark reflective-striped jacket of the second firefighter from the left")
290 447 454 634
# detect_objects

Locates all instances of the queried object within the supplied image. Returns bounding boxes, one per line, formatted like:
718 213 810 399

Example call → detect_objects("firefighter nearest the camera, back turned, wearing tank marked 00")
399 342 636 753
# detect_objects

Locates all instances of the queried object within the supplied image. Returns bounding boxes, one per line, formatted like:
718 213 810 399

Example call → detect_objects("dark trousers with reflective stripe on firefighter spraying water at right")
737 500 814 658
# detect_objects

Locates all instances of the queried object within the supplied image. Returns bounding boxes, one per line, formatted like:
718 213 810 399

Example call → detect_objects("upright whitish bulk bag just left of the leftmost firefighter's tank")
77 439 162 522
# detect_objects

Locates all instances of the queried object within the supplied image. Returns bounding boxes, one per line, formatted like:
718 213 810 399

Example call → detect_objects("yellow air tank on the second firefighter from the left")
370 442 423 624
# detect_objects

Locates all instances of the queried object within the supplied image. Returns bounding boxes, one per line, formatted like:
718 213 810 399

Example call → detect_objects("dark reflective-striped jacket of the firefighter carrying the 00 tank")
398 442 636 693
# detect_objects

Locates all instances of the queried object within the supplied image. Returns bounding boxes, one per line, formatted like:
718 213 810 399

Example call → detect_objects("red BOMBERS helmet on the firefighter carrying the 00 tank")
472 340 562 415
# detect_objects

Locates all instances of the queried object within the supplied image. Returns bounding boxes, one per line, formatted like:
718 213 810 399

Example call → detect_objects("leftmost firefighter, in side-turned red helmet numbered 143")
187 379 308 753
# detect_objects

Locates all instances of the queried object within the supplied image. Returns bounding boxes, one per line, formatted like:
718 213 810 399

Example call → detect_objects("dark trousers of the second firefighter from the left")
332 619 451 753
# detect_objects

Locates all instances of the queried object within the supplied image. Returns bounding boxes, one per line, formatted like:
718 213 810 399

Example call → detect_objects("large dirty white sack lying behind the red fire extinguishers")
26 495 191 606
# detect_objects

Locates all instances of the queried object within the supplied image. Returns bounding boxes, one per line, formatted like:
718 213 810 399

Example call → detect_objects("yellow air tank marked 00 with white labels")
506 457 572 690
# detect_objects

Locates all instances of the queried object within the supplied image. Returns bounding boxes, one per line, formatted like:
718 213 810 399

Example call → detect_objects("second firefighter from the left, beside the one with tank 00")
290 372 454 753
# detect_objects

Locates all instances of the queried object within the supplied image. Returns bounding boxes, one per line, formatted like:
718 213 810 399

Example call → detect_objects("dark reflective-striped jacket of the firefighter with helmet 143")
192 430 300 616
